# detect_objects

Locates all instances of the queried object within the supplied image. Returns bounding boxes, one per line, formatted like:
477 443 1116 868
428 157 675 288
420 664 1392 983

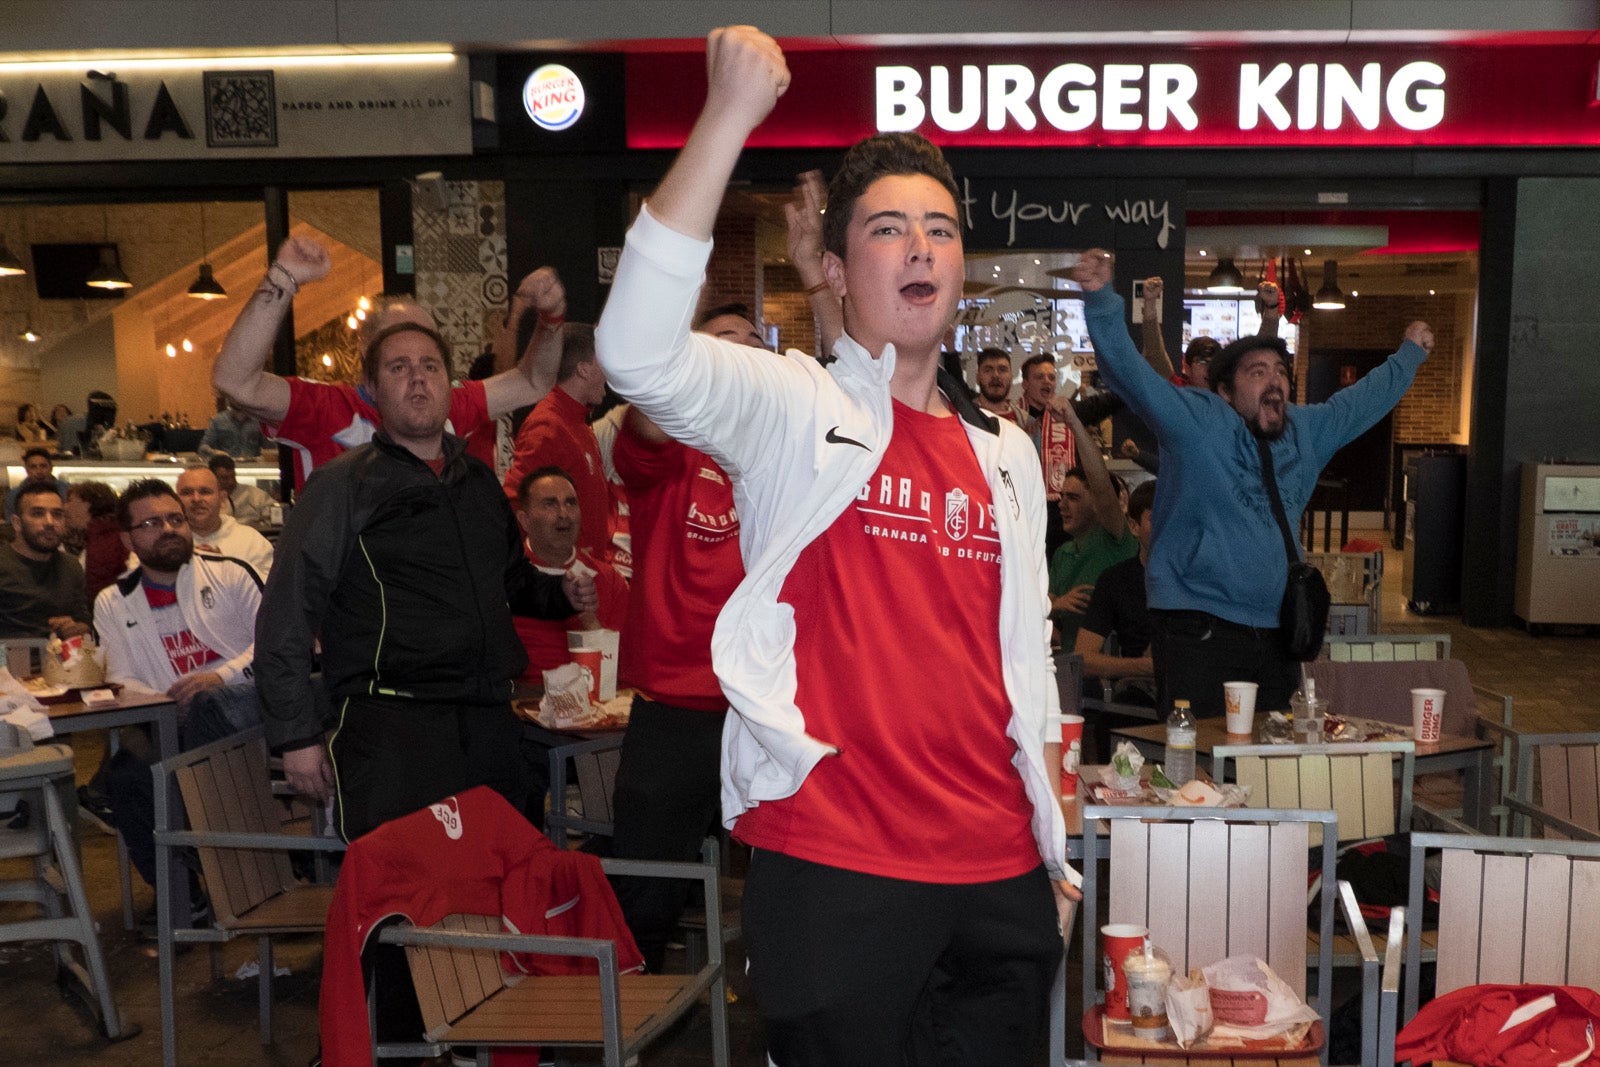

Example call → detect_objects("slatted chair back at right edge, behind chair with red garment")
1506 731 1600 841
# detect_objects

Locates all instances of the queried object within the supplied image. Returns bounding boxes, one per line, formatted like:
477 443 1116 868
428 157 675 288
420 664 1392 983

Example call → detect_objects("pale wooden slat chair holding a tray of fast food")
1083 805 1338 1065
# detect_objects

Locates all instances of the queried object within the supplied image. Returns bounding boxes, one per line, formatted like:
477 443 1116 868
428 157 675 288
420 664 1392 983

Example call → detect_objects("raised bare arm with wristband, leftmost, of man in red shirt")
211 237 330 422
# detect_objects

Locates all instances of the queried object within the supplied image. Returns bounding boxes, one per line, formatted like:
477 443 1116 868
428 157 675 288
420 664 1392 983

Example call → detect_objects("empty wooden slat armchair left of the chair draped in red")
152 726 344 1067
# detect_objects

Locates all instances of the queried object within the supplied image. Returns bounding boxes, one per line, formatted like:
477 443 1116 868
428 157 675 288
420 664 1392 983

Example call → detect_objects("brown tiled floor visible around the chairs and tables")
0 534 1600 1067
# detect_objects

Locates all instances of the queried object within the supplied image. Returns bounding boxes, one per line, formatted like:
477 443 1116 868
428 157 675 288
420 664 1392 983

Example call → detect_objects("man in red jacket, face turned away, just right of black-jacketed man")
504 323 616 560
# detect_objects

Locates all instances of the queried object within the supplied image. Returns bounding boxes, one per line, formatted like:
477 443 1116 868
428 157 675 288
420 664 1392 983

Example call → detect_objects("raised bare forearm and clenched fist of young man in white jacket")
650 26 789 240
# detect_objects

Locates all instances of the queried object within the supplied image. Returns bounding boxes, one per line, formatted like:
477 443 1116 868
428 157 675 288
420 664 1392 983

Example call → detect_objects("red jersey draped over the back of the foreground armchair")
320 785 643 1067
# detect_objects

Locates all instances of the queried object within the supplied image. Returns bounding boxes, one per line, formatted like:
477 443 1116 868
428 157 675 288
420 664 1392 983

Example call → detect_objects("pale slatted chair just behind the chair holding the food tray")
1211 741 1437 966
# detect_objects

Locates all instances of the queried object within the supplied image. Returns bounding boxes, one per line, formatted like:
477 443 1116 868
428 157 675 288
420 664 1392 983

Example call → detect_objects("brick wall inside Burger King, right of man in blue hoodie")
1296 293 1472 443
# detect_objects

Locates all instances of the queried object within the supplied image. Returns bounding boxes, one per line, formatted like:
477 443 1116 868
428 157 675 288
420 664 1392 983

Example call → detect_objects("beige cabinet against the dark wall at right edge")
1517 462 1600 627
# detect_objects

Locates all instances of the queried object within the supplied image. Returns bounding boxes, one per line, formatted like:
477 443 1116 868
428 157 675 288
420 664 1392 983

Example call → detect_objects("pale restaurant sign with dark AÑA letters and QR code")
0 53 472 163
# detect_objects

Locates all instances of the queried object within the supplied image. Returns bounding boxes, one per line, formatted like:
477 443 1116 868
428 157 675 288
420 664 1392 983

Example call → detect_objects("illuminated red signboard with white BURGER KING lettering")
627 45 1600 149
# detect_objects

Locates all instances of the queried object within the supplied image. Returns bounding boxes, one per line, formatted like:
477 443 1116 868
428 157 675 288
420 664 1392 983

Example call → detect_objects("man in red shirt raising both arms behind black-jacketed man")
211 237 566 491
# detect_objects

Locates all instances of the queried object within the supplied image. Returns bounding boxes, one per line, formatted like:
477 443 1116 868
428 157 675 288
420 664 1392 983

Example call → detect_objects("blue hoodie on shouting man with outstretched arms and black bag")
1083 286 1427 629
